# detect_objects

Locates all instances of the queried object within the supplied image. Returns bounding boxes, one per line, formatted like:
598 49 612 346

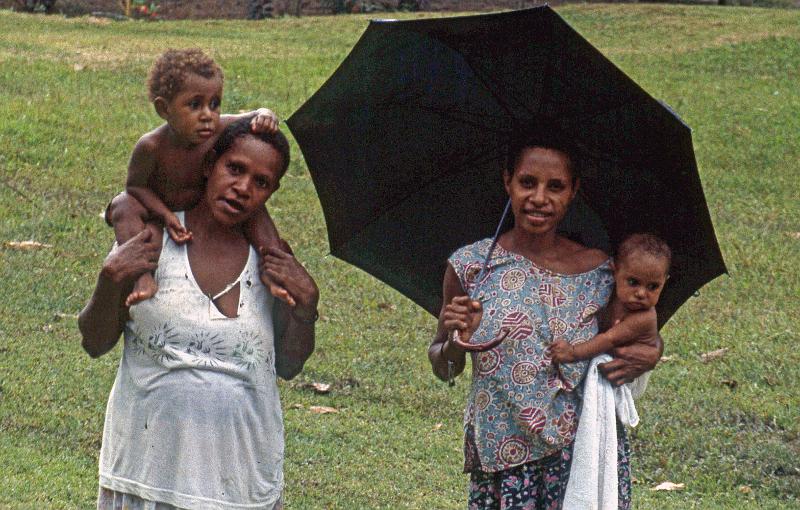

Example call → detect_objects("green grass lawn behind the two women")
0 4 800 509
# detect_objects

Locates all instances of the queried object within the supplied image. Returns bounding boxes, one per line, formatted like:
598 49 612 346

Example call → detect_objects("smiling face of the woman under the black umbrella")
505 147 578 235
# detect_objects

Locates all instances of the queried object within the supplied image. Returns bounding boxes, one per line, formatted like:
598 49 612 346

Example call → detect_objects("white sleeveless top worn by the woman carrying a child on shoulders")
98 213 284 510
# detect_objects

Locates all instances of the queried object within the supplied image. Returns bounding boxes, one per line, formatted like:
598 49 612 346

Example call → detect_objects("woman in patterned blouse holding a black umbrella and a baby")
428 139 662 509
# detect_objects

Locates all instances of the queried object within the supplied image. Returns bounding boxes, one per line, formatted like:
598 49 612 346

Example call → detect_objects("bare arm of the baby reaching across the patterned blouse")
549 310 656 363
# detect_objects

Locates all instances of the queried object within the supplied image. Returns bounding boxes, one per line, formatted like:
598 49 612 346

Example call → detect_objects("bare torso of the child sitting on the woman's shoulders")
147 127 216 211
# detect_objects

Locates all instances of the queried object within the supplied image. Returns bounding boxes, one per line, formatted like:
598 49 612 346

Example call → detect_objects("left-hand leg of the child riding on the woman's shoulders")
106 193 163 306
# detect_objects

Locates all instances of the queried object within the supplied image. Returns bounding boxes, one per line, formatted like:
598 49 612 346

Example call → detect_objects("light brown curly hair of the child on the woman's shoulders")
147 48 223 101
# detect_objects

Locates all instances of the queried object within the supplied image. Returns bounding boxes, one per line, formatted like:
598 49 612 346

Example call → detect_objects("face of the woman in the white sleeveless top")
206 135 282 225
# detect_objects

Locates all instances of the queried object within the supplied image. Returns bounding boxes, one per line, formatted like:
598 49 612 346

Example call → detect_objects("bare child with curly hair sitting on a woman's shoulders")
106 49 293 306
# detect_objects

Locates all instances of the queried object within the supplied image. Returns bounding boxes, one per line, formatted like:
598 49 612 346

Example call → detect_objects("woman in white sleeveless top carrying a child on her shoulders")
78 118 319 510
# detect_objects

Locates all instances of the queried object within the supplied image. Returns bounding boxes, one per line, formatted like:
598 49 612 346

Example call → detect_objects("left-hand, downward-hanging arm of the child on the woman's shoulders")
126 135 192 243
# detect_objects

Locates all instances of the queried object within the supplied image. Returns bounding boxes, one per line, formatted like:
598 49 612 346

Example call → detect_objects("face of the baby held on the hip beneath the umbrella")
614 252 668 312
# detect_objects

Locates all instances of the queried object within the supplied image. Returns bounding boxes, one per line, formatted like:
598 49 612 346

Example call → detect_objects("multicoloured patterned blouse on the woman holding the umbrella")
448 239 614 472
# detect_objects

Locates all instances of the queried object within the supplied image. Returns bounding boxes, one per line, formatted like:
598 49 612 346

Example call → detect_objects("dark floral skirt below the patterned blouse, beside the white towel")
468 424 631 510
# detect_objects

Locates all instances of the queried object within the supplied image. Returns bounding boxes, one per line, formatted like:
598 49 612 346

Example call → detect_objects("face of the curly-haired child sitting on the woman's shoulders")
159 74 222 145
